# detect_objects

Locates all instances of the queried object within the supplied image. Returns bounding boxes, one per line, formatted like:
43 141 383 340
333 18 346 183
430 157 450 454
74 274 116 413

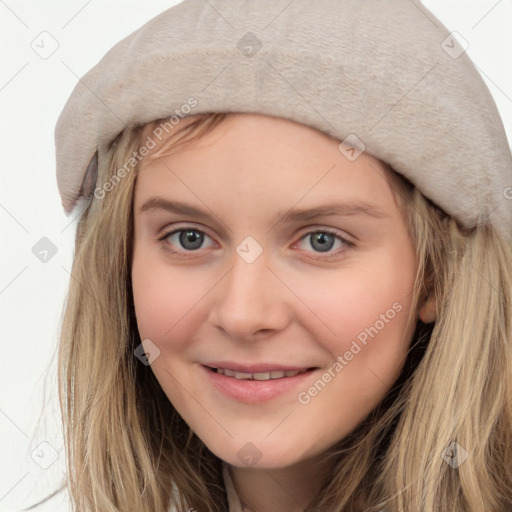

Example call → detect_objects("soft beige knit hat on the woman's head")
55 0 512 239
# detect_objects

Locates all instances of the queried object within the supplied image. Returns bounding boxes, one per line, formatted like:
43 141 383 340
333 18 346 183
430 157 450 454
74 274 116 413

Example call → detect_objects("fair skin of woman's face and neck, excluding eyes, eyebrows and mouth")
132 114 434 512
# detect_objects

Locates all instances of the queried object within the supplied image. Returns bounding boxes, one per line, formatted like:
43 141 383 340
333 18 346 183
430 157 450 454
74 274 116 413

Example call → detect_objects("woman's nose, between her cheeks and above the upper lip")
209 247 290 341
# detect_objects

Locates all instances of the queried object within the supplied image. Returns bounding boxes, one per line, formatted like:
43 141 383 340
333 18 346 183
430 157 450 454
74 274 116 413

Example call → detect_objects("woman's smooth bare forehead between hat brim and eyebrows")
136 114 400 218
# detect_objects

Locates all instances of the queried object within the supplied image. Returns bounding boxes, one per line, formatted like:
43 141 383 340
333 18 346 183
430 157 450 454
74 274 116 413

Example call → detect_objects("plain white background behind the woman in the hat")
0 0 512 512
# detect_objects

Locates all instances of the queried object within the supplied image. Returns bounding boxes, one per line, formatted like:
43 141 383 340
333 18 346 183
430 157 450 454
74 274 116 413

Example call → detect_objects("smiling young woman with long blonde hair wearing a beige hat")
31 0 512 512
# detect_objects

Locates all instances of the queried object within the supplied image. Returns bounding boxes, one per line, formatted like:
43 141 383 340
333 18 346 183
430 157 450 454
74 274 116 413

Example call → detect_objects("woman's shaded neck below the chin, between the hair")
229 458 330 512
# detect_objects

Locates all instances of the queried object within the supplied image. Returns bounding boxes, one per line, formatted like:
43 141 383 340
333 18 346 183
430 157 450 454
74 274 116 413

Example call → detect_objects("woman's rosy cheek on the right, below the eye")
289 246 416 370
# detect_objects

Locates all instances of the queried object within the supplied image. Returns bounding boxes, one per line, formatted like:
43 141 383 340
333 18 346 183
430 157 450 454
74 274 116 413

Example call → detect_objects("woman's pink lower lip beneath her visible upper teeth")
201 366 315 404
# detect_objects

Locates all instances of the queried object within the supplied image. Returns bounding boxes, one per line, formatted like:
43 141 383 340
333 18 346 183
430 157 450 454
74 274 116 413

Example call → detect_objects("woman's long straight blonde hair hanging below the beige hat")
30 114 512 512
